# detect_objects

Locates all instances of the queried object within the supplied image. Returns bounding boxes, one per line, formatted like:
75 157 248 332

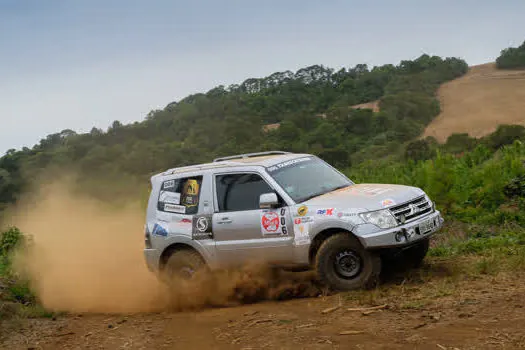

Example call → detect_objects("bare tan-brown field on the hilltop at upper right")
424 63 525 142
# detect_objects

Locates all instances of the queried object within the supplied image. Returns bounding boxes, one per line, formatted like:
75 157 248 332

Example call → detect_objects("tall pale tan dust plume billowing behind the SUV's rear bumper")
12 180 167 312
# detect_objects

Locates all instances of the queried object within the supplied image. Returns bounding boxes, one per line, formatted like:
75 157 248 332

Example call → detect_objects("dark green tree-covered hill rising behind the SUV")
0 55 468 210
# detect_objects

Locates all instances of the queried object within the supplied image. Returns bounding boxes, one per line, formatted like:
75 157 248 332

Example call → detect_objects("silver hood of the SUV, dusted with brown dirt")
303 184 425 211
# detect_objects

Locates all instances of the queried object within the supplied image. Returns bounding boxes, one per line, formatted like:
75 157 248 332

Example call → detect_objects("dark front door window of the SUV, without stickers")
215 174 274 212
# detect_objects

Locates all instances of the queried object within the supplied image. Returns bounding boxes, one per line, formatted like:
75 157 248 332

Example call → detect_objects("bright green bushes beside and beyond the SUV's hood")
347 141 525 225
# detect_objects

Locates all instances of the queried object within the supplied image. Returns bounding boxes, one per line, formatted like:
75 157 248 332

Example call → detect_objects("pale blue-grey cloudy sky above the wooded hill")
0 0 525 155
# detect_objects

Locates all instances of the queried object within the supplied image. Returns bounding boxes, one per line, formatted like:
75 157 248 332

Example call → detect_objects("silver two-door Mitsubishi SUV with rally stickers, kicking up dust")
144 151 443 290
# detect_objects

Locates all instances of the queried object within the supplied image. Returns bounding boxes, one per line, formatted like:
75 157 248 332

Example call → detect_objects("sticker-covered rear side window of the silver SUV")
157 176 202 215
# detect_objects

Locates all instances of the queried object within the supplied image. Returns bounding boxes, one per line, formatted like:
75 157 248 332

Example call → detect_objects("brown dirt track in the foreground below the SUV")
3 268 525 350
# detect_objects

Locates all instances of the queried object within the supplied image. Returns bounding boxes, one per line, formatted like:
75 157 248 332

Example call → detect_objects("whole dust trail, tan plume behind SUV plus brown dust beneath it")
6 181 320 313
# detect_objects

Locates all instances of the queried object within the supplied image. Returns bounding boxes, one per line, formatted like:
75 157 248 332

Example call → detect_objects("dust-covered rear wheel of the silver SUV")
162 249 206 284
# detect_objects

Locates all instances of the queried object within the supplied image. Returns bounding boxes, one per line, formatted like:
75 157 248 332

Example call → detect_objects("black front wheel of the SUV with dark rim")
315 233 381 291
